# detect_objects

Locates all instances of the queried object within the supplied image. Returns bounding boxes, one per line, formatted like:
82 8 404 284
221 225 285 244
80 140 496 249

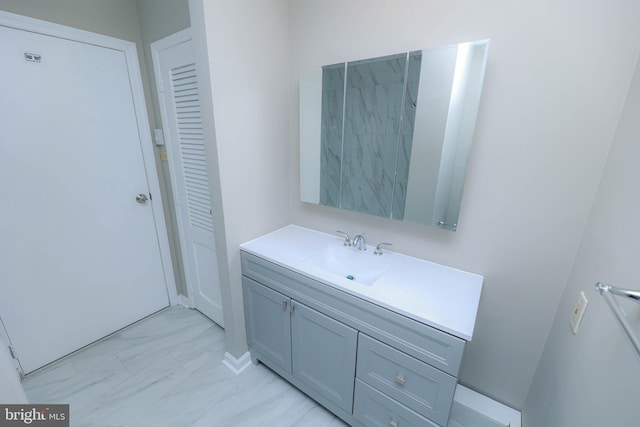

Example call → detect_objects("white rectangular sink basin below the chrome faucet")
303 244 389 286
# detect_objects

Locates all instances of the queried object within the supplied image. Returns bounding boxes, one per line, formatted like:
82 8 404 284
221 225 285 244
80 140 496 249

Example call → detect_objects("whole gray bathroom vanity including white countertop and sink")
241 225 483 427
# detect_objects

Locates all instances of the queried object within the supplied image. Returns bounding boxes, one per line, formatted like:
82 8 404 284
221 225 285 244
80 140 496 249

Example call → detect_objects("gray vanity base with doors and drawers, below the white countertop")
241 251 465 427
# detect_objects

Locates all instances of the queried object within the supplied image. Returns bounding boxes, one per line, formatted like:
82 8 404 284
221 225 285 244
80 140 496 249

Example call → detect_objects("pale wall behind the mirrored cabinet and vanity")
288 0 640 408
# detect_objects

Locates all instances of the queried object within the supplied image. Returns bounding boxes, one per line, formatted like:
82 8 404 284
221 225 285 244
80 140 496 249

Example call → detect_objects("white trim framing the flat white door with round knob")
0 11 179 306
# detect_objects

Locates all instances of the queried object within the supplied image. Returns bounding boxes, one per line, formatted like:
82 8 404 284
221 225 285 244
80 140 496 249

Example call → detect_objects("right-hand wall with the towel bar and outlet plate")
523 55 640 427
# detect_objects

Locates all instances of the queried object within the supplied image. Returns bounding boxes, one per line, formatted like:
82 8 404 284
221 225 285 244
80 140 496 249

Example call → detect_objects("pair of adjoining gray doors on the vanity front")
243 277 358 413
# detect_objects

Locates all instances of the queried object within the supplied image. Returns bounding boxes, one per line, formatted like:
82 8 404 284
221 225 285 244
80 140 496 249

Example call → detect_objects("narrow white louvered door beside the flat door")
151 30 224 326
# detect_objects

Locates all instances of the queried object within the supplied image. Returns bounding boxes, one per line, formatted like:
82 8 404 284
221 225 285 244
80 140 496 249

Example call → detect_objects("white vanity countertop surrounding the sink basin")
240 225 484 341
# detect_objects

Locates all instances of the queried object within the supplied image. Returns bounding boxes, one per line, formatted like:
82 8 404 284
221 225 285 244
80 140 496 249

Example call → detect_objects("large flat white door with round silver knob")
0 18 168 373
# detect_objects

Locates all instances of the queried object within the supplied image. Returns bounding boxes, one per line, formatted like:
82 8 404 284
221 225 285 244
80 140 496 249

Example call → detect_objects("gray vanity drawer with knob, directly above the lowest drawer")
356 333 457 425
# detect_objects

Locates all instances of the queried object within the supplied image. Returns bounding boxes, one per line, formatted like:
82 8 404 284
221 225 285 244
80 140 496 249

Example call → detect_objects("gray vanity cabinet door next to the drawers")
291 301 358 413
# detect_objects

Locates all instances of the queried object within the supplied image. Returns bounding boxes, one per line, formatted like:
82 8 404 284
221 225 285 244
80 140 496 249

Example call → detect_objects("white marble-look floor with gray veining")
23 307 345 427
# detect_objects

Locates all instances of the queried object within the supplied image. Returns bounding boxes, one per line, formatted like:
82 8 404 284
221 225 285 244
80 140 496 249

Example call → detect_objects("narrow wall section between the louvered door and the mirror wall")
190 0 297 357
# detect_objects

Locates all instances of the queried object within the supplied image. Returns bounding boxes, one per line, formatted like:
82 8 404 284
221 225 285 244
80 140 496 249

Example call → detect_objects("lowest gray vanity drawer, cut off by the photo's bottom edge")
353 380 438 427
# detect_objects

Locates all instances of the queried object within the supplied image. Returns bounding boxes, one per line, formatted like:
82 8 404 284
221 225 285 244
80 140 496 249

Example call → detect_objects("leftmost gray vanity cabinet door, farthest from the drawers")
242 277 291 372
